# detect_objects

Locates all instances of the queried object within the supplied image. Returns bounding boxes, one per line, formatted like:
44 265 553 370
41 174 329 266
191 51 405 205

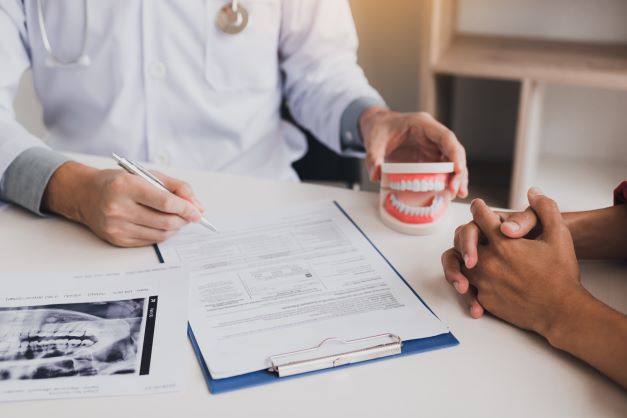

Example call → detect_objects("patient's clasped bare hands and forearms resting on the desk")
442 183 627 388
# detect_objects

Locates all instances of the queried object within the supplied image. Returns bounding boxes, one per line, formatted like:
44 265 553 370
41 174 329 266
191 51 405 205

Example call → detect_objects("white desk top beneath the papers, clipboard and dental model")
0 156 627 418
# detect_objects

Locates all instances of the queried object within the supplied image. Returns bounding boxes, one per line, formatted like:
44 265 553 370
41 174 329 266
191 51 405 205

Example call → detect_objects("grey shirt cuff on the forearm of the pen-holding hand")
0 147 69 216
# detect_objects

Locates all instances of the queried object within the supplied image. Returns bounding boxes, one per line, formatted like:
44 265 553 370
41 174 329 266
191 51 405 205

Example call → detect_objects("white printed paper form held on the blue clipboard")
159 201 448 379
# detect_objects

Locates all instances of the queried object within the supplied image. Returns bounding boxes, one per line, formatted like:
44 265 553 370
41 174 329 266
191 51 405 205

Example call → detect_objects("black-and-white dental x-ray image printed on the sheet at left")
0 298 144 380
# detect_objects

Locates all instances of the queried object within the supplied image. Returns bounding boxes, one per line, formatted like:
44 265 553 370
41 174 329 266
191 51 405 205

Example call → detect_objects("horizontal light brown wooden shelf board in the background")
433 34 627 90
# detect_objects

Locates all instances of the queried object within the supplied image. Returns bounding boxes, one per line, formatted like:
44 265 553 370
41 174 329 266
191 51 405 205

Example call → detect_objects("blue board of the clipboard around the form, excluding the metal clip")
154 201 459 394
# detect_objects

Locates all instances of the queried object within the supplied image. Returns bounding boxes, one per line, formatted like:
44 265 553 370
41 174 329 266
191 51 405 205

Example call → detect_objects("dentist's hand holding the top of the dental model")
359 107 468 198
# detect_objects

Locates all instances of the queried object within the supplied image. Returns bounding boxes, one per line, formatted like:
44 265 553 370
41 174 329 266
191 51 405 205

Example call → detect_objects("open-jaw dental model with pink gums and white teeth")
379 163 453 235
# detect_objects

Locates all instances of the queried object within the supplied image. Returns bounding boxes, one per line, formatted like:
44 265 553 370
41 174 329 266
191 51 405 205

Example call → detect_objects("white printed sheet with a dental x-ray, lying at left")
0 265 188 401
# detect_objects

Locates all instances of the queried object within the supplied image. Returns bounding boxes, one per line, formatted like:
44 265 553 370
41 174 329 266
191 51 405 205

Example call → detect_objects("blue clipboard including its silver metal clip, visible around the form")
154 201 459 394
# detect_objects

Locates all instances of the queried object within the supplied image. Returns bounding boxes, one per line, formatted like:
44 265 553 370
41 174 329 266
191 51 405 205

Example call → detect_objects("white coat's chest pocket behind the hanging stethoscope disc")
205 0 281 91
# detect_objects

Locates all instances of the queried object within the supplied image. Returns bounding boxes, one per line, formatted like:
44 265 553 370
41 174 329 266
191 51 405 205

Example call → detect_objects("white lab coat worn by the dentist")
0 0 380 179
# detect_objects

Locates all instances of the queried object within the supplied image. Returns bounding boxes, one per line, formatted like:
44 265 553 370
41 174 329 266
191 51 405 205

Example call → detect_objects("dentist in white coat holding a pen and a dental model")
0 0 468 246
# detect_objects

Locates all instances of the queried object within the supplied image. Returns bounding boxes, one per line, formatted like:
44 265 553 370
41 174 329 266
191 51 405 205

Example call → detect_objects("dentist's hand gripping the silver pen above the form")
42 162 203 247
